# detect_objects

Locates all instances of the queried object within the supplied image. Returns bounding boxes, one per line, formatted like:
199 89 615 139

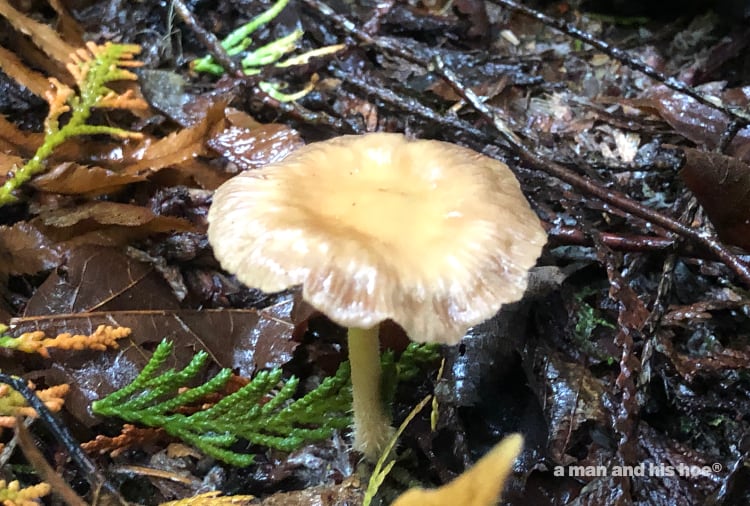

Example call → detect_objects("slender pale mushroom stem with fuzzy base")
348 325 394 462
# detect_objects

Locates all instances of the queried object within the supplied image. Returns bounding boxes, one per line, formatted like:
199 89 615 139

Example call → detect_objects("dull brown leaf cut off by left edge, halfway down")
0 221 61 276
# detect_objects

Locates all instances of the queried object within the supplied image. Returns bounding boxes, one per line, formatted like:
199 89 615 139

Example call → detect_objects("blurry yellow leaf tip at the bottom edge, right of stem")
392 434 523 506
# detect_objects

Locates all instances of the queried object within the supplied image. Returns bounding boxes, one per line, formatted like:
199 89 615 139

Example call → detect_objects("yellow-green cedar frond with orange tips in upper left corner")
0 42 147 206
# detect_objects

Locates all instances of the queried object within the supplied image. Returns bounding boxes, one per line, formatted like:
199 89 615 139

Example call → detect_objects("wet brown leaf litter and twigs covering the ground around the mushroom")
0 0 750 505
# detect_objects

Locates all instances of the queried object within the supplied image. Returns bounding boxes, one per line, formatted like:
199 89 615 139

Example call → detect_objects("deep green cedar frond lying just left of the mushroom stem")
92 341 352 467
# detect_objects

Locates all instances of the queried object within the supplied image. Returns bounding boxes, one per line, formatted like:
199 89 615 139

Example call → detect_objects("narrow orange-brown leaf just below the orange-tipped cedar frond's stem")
32 162 146 195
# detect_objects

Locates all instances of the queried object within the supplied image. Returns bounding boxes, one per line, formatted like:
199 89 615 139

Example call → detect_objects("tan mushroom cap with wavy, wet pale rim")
208 133 546 344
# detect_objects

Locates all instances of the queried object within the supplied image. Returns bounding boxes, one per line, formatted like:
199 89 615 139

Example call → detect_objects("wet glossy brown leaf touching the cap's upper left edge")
208 123 303 170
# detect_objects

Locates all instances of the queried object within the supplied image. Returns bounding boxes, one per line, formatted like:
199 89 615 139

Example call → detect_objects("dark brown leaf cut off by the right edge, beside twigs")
680 145 750 251
